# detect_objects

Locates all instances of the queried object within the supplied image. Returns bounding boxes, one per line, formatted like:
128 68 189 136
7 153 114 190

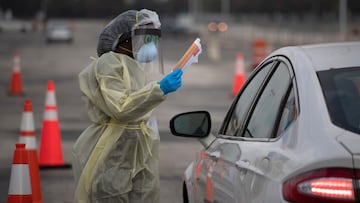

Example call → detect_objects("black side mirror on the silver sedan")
170 111 211 138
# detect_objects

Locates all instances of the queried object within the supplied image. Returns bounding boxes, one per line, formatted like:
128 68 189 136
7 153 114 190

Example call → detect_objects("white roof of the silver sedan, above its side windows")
270 42 360 71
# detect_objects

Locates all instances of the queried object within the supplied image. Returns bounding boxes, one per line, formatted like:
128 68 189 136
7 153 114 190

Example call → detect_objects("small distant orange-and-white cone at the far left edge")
9 51 23 96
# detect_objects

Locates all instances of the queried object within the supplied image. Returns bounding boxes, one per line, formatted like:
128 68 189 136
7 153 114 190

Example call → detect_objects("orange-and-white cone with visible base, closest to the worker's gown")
39 80 70 169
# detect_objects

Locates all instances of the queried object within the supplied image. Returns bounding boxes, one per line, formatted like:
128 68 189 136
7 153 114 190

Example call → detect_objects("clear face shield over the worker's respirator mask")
131 28 164 81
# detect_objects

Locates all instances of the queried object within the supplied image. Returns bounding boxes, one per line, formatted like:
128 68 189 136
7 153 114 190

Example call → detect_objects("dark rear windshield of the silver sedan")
318 67 360 134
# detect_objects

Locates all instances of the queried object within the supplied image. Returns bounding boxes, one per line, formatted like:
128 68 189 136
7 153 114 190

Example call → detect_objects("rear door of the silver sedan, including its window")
235 62 297 203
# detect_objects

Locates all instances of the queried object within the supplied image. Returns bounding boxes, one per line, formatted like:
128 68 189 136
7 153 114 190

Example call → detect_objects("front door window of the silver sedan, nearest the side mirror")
225 63 273 135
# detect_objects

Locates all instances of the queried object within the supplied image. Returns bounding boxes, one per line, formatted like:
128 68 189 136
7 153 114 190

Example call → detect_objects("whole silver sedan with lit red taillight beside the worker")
170 42 360 203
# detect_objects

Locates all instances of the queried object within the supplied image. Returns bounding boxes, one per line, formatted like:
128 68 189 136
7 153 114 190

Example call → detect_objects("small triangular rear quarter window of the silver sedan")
276 86 298 137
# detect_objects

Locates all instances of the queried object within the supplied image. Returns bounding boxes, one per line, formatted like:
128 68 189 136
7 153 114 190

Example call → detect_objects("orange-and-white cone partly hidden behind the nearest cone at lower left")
19 99 42 203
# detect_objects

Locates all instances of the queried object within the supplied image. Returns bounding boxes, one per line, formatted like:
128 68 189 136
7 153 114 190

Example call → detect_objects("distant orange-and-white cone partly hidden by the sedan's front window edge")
232 53 246 96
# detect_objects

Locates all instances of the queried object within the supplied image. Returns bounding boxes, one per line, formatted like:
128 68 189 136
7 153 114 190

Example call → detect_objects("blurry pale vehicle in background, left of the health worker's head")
46 22 73 44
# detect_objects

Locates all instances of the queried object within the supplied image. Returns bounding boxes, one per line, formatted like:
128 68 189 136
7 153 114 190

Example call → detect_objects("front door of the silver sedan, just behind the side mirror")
196 61 274 203
